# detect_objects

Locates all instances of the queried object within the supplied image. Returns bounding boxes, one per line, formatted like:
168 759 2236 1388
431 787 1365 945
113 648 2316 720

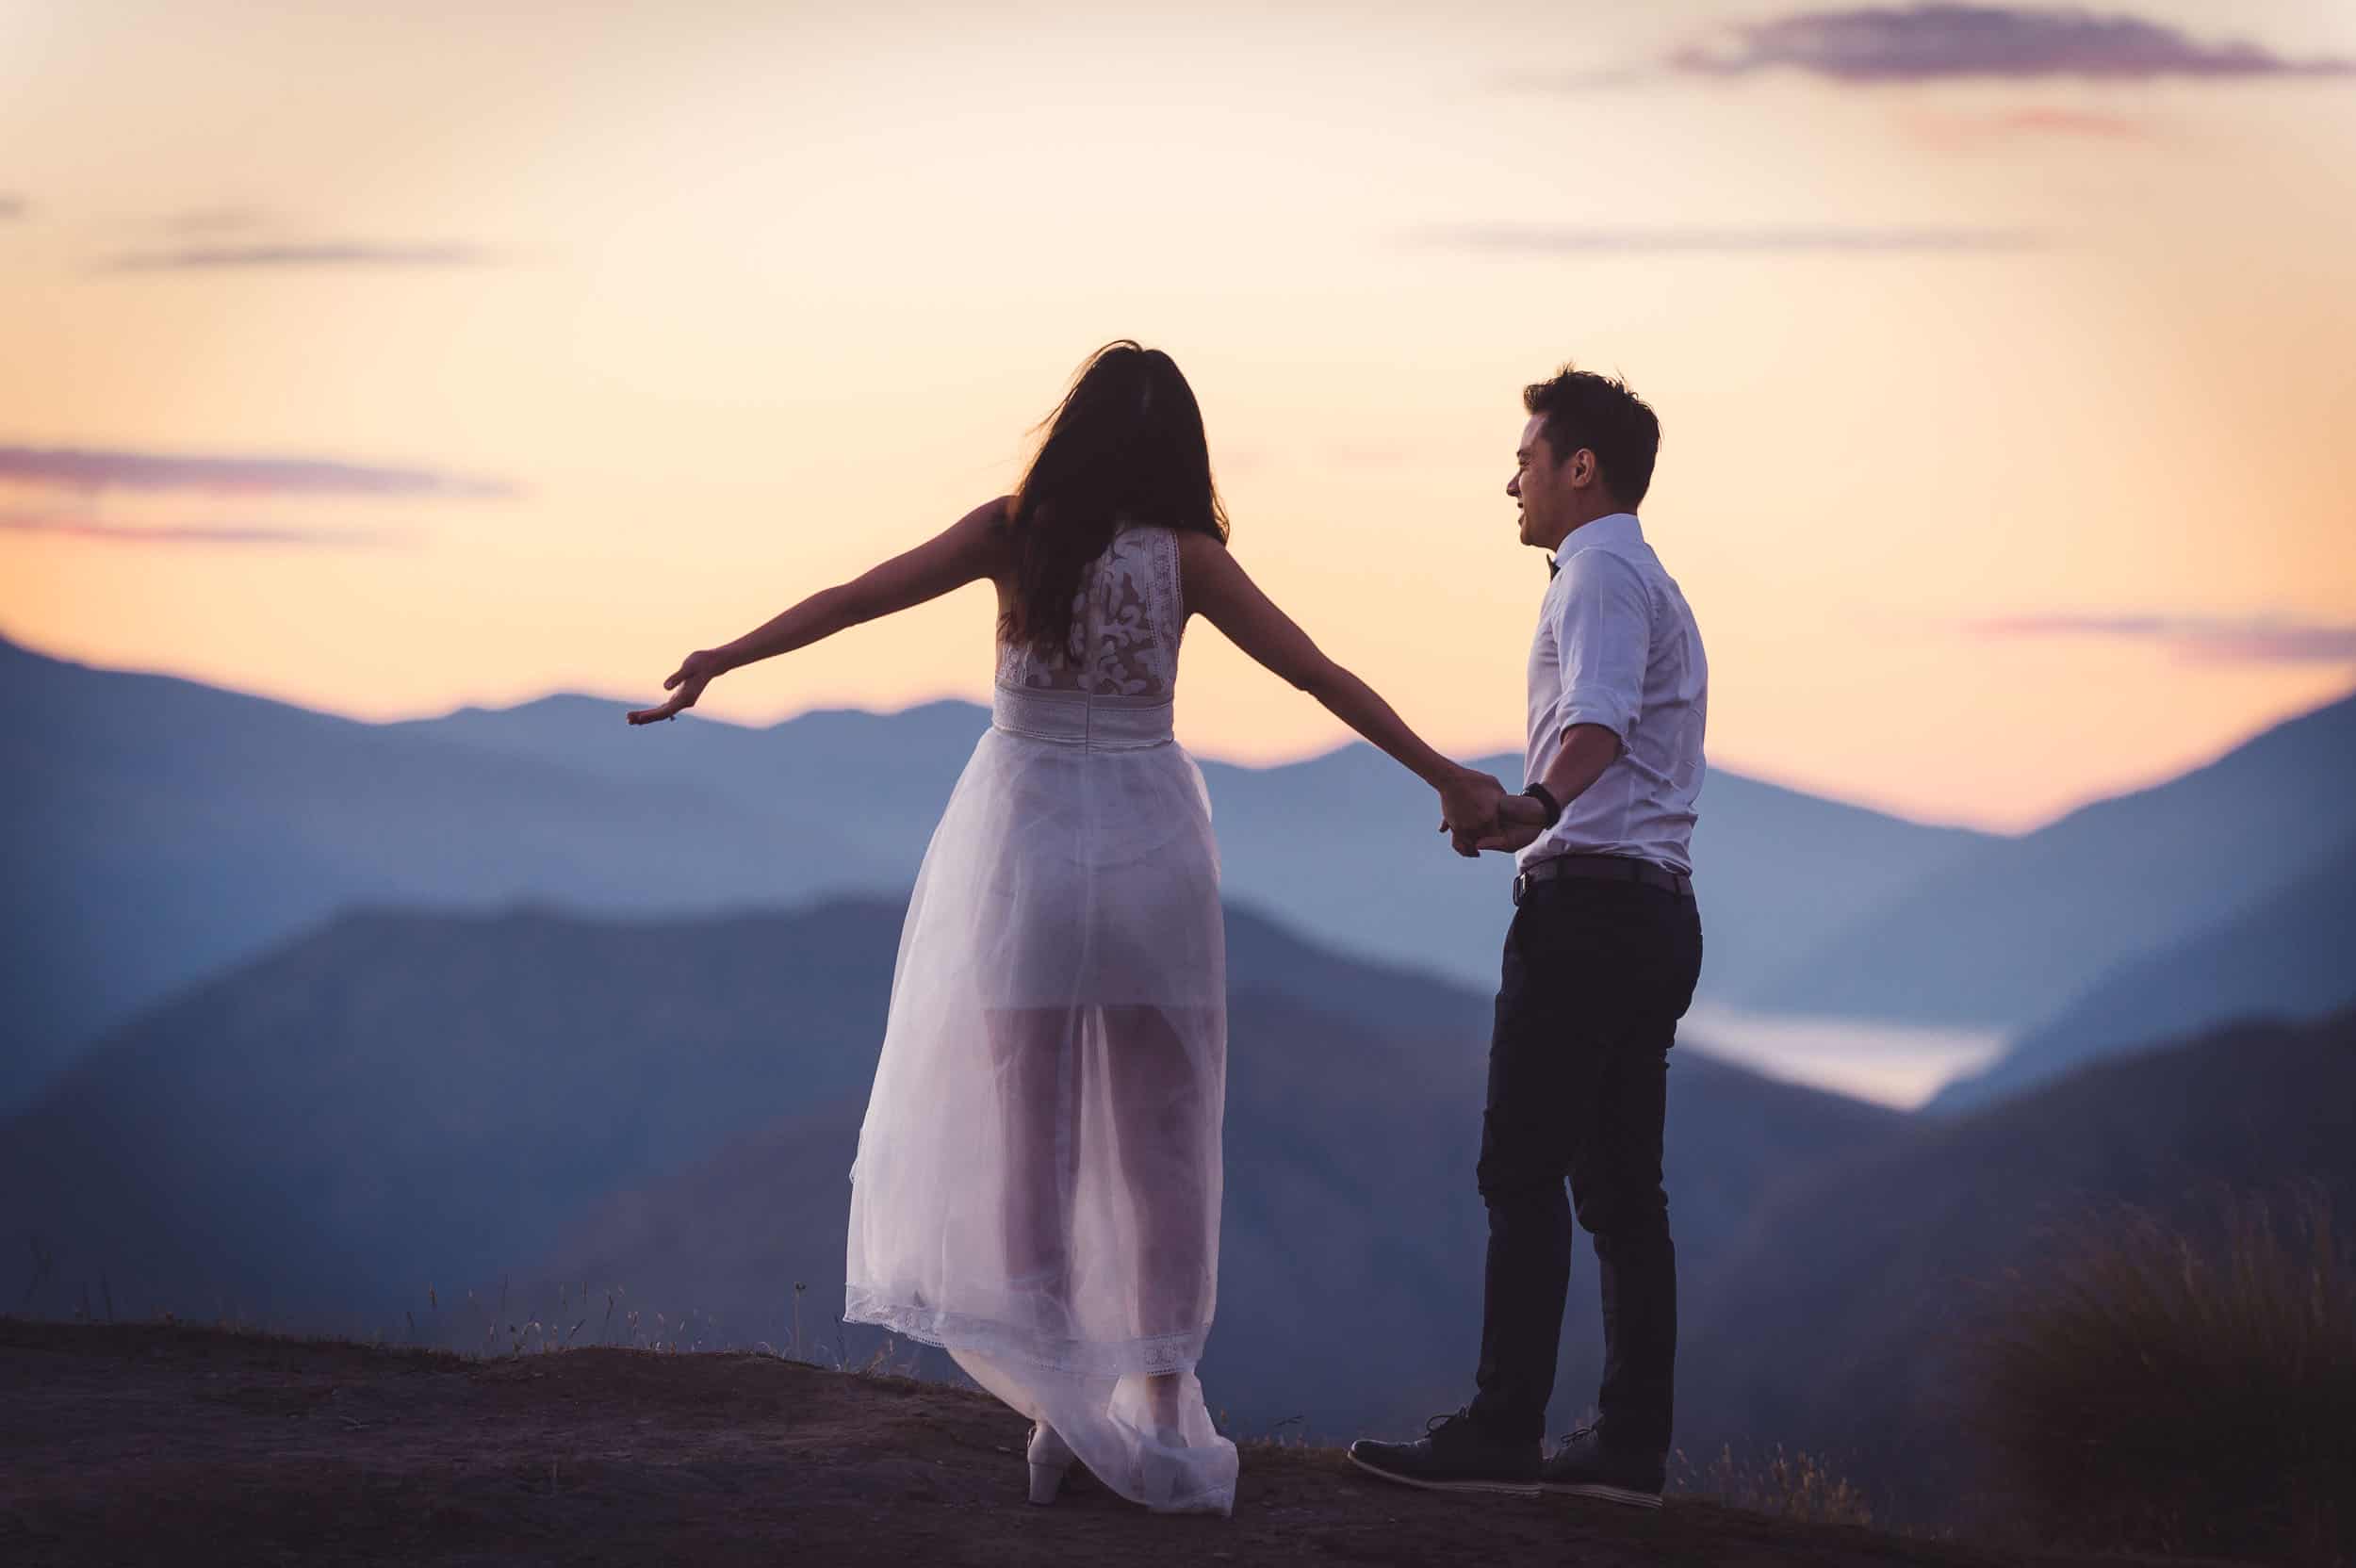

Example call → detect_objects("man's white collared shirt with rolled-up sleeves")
1517 511 1710 874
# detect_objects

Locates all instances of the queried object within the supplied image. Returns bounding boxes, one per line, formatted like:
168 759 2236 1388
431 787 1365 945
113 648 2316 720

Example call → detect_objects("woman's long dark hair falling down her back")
999 336 1228 660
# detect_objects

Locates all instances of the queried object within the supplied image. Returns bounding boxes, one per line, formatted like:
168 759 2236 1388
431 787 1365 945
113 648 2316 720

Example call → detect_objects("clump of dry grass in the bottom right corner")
1977 1194 2356 1563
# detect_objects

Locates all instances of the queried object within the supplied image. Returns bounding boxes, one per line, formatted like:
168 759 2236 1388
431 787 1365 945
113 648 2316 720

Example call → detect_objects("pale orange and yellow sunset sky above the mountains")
0 0 2356 828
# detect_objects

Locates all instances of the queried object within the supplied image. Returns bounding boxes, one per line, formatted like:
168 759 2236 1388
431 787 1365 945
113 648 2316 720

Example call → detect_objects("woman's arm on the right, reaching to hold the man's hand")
1178 534 1506 857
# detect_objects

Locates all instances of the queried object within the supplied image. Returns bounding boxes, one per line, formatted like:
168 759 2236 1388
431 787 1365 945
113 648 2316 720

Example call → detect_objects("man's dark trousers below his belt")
1473 878 1701 1460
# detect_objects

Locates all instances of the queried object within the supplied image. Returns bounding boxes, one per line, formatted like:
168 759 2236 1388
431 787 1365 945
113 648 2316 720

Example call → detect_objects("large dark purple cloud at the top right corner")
1668 5 2356 82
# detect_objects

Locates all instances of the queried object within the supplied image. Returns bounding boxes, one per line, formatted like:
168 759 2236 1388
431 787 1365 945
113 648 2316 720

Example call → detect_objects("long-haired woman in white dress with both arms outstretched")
630 339 1503 1514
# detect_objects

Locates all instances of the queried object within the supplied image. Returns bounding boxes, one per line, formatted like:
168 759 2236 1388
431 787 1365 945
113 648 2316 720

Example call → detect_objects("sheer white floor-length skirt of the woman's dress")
843 688 1237 1514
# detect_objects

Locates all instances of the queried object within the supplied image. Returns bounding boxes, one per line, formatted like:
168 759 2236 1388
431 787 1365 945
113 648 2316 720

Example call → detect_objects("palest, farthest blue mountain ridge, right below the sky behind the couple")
401 673 1996 998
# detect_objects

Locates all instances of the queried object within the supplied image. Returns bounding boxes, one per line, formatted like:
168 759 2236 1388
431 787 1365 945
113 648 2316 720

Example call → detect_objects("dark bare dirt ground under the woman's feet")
0 1318 2215 1568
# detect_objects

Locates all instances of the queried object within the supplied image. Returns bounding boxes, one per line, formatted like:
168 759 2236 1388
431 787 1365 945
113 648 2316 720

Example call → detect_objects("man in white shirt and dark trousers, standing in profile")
1350 368 1709 1507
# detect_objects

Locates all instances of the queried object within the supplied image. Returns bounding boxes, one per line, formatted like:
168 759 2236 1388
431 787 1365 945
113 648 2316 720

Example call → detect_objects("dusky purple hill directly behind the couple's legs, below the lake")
531 991 1904 1439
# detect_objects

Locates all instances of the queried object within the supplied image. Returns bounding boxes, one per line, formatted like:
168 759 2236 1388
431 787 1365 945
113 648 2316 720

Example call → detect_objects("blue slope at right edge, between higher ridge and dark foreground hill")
1922 842 2356 1116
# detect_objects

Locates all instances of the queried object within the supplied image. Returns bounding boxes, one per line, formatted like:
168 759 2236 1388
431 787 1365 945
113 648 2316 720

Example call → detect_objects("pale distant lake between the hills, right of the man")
1677 1003 2010 1111
